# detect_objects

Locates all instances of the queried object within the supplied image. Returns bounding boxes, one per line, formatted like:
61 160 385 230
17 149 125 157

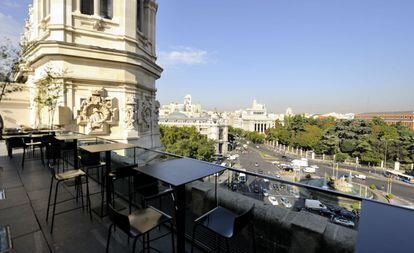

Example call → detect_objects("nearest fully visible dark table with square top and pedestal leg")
136 158 225 252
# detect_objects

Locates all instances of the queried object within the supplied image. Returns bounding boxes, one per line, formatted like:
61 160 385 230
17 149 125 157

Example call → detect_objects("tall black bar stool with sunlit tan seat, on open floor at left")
46 160 92 233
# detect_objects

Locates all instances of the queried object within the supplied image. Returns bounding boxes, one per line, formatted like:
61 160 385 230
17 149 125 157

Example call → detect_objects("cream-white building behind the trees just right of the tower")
159 95 229 155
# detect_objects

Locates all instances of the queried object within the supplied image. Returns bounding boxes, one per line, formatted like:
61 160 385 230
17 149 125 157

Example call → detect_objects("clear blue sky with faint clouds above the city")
0 0 414 113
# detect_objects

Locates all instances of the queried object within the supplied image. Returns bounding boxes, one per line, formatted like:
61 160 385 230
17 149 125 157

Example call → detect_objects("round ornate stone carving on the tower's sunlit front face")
77 89 118 135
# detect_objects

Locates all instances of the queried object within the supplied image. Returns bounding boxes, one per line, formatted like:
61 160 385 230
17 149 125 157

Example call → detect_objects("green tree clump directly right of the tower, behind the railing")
160 125 215 161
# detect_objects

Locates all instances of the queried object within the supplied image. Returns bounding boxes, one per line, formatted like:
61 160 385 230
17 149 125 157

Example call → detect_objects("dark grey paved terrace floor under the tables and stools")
0 141 201 253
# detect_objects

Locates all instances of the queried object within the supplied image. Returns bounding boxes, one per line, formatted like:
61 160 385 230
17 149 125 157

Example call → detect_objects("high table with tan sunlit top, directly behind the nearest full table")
80 143 136 217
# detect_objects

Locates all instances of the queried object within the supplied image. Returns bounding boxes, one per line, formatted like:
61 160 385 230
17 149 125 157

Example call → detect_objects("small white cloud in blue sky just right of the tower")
158 47 209 66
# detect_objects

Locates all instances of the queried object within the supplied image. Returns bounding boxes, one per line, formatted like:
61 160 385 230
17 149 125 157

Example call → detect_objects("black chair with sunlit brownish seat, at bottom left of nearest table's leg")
106 206 175 253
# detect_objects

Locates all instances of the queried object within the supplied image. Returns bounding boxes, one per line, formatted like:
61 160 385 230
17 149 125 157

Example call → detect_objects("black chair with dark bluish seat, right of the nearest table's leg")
191 205 256 253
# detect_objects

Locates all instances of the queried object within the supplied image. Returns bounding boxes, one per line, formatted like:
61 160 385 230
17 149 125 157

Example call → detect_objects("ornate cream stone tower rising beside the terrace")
18 0 162 148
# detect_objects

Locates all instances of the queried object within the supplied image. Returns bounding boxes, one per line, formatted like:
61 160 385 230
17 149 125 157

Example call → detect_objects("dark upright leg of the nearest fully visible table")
175 185 185 252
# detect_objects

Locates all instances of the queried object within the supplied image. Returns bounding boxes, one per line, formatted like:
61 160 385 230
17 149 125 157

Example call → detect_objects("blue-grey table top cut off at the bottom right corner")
355 200 414 253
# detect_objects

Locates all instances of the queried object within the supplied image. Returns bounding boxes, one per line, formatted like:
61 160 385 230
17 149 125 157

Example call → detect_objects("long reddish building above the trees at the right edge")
355 111 414 130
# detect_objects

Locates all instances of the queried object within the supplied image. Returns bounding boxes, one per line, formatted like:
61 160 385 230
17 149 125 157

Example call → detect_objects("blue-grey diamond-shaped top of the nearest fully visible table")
135 158 225 186
